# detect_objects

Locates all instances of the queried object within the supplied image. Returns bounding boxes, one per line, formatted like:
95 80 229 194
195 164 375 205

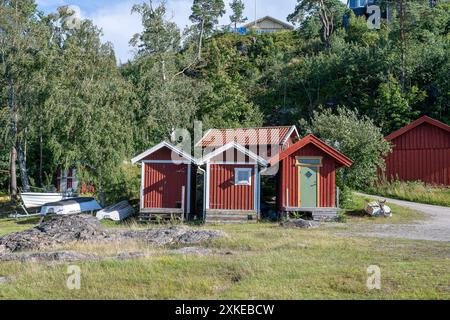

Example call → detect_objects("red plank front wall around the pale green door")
278 144 336 209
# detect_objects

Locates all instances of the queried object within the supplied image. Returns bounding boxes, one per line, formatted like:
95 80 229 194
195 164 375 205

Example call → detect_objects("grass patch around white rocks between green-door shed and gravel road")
344 194 425 224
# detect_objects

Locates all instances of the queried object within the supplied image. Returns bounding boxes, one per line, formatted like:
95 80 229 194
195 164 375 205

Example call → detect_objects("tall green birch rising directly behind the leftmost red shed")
126 1 206 151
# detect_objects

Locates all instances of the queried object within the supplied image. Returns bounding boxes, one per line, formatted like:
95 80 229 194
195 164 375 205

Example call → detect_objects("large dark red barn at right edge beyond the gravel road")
385 116 450 186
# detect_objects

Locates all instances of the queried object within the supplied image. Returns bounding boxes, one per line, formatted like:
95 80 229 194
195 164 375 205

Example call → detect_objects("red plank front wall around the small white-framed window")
209 164 255 210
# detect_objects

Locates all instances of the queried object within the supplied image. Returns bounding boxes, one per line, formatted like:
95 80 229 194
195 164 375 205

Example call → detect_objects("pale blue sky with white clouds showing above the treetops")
36 0 348 62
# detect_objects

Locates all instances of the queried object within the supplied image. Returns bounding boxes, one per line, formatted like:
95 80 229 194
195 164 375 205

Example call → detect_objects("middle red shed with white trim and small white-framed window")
201 142 267 221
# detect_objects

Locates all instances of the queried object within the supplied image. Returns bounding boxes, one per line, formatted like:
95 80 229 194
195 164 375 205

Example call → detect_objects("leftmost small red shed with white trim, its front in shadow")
131 141 197 219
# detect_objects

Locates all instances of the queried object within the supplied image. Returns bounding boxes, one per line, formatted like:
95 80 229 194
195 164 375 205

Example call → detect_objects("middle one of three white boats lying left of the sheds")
41 198 102 216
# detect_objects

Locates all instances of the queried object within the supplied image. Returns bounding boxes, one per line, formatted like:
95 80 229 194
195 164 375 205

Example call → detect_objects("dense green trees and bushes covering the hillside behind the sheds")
0 0 450 200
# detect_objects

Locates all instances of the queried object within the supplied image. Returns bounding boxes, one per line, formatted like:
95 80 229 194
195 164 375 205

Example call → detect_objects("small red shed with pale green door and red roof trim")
269 135 352 219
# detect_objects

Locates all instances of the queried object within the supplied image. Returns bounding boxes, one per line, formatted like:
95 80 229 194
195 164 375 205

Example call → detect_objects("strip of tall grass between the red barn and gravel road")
367 181 450 207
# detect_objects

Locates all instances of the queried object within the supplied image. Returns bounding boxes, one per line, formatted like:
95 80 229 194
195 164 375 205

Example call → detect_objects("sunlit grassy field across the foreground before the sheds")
0 197 450 299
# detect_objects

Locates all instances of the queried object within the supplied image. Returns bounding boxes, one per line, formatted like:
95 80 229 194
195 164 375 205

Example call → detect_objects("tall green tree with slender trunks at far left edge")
0 0 46 198
